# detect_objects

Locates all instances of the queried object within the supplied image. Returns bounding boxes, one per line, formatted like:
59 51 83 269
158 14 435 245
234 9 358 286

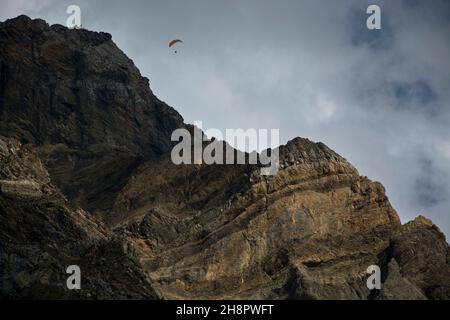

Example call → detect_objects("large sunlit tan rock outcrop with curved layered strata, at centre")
114 139 400 299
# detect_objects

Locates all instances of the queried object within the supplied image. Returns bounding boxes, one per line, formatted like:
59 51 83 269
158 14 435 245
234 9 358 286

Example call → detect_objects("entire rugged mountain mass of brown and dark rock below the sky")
0 16 450 299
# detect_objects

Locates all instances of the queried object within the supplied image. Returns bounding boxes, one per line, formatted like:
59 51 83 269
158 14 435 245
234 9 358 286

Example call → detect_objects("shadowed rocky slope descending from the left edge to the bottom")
0 138 158 299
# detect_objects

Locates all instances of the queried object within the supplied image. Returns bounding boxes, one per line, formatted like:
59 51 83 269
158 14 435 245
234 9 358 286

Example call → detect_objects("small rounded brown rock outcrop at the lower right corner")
380 216 450 299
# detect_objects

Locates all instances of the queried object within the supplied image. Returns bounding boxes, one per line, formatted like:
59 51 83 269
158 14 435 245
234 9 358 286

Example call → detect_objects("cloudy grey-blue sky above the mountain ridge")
0 0 450 239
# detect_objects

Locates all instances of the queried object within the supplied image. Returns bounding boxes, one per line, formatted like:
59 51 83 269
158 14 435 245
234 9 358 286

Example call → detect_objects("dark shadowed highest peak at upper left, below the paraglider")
0 16 184 211
